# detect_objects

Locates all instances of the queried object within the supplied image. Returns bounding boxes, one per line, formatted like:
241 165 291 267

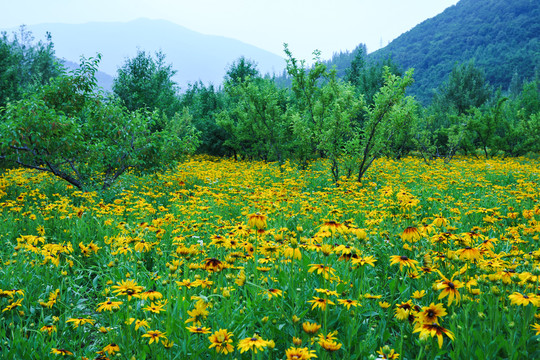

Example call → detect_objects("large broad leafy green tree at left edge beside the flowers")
0 56 198 191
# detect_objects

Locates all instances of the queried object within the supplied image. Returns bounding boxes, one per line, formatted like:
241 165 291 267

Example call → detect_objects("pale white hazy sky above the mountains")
0 0 458 60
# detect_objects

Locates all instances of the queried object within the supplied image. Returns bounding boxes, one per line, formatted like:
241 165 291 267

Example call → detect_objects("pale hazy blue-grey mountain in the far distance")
8 19 285 88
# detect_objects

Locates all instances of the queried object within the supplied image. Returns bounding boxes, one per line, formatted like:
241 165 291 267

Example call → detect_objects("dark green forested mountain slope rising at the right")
324 0 540 103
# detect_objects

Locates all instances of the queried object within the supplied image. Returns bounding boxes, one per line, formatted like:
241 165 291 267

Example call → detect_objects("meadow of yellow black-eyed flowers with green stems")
0 157 540 360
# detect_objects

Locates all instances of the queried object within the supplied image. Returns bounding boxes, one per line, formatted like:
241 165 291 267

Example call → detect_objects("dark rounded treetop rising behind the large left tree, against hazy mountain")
113 50 181 117
